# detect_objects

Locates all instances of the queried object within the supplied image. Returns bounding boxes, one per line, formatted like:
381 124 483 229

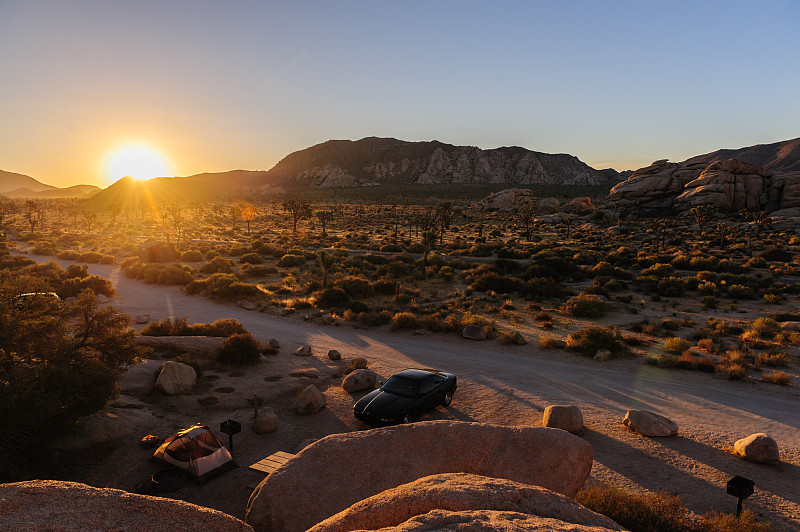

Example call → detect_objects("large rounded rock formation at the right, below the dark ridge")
608 159 800 216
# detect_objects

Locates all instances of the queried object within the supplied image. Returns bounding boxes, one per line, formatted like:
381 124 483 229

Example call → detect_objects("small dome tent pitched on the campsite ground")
152 423 236 483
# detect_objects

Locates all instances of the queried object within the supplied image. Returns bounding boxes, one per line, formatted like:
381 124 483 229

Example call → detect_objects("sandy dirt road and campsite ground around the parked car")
25 257 800 530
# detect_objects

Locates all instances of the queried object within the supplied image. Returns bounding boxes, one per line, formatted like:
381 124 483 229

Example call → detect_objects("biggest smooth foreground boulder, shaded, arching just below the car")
246 421 593 531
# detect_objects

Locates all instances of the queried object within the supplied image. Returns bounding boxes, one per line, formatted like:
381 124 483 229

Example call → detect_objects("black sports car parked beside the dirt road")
353 369 457 426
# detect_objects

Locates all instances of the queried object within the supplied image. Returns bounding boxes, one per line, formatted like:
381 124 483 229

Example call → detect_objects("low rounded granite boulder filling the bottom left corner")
0 480 252 532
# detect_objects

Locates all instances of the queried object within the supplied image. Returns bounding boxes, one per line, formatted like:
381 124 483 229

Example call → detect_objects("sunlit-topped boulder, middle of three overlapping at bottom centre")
309 473 624 532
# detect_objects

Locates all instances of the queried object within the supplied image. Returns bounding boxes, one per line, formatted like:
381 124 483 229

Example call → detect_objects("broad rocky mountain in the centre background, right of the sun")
254 137 619 187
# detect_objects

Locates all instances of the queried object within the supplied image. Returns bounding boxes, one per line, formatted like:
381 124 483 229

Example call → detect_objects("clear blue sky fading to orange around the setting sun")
0 0 800 187
